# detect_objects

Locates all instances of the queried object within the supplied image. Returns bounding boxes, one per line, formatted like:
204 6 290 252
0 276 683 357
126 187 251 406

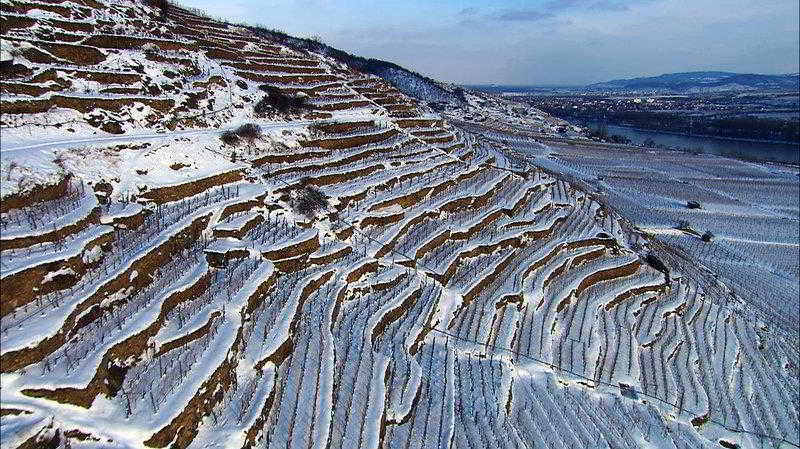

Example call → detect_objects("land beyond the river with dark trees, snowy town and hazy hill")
468 72 800 143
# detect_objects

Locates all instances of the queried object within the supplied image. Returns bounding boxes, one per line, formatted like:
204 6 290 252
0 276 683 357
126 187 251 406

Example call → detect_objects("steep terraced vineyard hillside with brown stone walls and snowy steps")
0 0 800 449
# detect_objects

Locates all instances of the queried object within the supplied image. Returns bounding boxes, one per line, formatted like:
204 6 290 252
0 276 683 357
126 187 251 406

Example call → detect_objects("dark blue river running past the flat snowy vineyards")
580 121 800 164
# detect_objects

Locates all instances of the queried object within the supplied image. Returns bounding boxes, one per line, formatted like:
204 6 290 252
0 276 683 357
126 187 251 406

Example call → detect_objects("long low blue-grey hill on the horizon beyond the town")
586 72 800 92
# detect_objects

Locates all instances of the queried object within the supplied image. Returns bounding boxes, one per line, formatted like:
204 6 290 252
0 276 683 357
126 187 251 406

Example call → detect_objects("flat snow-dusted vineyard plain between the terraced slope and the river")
486 132 800 333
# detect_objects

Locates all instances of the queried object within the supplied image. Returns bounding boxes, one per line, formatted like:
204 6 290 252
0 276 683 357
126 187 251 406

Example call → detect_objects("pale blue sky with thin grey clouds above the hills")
179 0 800 84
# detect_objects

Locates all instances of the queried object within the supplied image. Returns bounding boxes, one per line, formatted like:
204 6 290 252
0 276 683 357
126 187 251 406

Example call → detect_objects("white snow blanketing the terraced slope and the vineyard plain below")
0 0 798 449
